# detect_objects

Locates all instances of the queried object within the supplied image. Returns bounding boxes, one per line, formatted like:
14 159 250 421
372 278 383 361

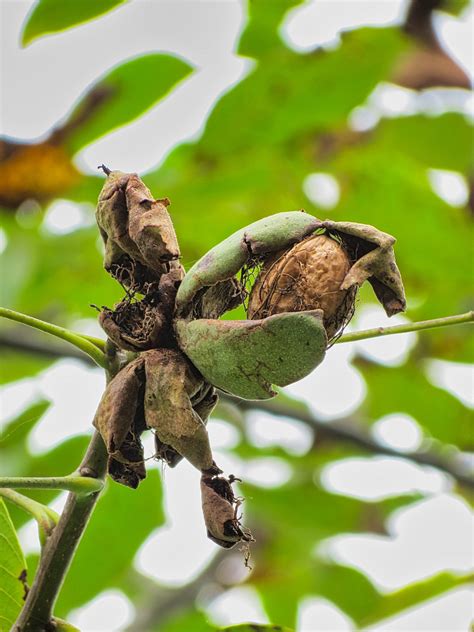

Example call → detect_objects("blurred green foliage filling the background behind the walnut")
0 0 473 632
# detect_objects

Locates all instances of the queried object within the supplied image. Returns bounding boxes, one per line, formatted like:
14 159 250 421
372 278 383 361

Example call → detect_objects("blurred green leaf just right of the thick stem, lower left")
56 470 165 617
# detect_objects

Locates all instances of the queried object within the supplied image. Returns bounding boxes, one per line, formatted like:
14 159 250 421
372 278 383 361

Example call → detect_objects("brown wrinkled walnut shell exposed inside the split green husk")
247 235 355 339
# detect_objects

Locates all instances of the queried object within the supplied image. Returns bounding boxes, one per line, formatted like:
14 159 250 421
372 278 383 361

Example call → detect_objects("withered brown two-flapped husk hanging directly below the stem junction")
94 349 220 487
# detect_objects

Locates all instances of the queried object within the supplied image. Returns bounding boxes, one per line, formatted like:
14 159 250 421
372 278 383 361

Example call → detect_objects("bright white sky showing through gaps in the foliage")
0 0 473 632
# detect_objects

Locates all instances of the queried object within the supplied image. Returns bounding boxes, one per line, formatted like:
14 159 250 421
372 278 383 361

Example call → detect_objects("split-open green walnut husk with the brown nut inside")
175 211 405 399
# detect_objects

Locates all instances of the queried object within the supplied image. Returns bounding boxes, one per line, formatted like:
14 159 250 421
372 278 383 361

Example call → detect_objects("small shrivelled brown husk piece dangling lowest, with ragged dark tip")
201 474 253 549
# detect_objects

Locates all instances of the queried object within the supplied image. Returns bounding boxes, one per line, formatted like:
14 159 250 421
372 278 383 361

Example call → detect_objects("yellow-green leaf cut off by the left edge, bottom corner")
0 498 27 632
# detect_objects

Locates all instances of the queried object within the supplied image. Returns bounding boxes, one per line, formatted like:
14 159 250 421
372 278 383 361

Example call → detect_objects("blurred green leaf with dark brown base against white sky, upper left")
67 53 192 154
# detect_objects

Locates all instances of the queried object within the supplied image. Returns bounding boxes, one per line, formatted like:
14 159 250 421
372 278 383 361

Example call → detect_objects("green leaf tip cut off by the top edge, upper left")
21 0 127 46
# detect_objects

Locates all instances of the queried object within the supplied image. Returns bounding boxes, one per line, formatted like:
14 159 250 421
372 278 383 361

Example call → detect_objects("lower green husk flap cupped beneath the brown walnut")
176 310 327 399
